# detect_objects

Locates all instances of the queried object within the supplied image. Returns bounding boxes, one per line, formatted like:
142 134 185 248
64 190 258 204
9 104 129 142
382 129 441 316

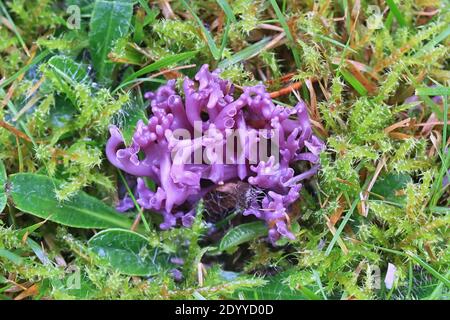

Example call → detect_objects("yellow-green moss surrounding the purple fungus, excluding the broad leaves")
0 0 450 299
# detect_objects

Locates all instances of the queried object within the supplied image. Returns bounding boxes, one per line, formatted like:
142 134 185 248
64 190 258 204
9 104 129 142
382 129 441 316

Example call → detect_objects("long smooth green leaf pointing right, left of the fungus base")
9 173 132 229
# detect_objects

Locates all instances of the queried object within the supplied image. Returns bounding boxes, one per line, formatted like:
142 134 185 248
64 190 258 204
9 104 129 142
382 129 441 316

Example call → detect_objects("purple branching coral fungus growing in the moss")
106 65 324 243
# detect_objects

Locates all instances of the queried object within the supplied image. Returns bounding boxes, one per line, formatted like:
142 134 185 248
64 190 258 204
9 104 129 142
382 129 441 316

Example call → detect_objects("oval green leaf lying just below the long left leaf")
89 229 170 276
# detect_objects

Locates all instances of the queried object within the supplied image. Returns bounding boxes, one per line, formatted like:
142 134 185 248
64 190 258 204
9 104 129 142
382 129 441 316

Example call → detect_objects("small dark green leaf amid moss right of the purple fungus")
372 173 412 203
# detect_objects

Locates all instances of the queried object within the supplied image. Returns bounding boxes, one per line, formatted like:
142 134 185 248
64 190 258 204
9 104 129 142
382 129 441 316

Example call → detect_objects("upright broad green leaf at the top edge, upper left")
89 0 133 83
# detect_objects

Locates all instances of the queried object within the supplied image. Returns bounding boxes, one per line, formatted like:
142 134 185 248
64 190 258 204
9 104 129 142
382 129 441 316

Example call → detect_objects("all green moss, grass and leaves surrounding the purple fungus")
0 0 450 300
